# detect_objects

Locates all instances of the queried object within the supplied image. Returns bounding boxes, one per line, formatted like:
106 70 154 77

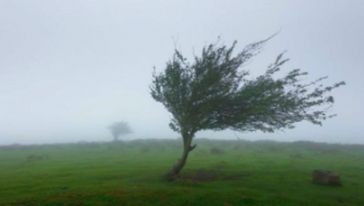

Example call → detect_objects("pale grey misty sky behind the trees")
0 0 364 144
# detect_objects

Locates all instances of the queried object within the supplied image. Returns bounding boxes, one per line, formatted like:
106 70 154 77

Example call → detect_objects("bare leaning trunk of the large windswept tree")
166 136 196 181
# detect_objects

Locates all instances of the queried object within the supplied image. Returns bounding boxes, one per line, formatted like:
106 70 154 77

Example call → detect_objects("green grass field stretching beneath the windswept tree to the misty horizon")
0 140 364 206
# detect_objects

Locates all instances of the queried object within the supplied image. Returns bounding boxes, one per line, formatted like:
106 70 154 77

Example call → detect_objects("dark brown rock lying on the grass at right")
312 170 341 186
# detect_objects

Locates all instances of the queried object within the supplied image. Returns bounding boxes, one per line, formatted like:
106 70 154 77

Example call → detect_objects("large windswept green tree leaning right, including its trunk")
150 38 345 179
